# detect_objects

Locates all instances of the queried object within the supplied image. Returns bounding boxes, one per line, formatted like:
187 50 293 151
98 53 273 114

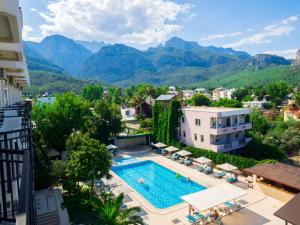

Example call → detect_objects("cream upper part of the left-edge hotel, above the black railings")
0 0 29 105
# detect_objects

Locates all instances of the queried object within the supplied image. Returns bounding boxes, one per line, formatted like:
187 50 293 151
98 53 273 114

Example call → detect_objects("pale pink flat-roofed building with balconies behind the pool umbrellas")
179 107 252 152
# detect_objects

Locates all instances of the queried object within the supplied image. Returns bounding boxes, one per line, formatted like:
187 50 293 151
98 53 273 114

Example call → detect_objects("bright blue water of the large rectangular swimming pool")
112 160 206 209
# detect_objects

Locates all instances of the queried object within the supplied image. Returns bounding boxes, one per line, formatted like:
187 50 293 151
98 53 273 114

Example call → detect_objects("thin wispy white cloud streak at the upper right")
223 16 299 48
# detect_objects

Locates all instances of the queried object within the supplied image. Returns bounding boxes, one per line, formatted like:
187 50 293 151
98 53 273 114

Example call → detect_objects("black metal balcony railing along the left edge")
0 102 36 225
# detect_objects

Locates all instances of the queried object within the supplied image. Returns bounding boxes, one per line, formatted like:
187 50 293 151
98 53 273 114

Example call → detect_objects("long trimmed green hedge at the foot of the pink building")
185 146 276 169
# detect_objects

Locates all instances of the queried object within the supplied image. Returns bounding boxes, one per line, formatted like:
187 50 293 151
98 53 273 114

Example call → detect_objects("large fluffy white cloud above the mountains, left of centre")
40 0 191 45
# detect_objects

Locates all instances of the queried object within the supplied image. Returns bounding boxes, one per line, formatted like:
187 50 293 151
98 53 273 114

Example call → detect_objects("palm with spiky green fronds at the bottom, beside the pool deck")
95 193 144 225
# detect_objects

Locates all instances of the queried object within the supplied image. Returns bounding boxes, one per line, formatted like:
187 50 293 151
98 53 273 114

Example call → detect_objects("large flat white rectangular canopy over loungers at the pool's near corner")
181 183 247 211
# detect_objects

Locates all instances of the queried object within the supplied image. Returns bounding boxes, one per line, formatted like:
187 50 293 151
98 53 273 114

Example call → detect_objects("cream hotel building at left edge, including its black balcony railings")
0 0 36 225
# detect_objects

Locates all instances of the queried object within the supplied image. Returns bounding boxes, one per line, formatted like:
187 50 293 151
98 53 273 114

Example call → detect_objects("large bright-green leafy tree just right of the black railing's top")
32 93 91 151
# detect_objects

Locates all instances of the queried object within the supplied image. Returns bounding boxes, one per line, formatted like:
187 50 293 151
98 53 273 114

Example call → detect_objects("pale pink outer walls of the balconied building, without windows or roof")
178 109 251 152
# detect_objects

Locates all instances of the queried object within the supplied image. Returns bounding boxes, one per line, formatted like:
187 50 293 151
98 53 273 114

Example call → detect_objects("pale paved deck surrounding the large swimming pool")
110 150 284 225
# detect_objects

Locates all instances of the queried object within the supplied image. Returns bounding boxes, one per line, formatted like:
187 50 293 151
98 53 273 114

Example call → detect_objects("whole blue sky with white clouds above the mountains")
20 0 300 58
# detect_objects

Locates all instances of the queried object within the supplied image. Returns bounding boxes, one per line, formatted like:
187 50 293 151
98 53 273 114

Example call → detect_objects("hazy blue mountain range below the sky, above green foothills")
24 35 298 89
